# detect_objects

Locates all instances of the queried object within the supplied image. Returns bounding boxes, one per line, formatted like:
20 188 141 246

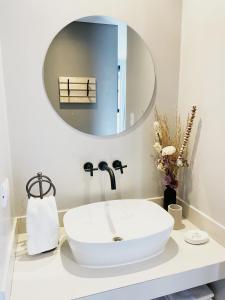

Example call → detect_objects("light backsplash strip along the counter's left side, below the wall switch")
0 218 17 300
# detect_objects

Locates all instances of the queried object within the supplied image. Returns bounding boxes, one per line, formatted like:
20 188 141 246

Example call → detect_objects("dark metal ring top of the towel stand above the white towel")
26 172 56 199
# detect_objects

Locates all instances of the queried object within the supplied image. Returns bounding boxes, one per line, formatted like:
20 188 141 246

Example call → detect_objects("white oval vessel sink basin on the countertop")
64 199 174 268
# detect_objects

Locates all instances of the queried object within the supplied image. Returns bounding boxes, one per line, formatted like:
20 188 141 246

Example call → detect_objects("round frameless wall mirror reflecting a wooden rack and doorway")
43 16 155 136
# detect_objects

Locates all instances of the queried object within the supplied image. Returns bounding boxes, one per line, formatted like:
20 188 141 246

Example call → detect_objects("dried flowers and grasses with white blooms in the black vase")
154 106 197 189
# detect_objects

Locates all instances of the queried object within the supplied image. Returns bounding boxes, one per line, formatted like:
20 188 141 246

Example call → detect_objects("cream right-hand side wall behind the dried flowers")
179 0 225 225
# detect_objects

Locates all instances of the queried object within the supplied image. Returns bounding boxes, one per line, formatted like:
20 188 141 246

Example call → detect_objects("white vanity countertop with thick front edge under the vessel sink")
11 220 225 300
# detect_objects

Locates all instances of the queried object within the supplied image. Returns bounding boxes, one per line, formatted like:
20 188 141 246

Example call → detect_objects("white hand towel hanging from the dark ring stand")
26 196 59 255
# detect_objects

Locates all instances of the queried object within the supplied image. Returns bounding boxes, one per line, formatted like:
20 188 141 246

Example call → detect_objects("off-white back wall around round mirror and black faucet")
0 0 181 215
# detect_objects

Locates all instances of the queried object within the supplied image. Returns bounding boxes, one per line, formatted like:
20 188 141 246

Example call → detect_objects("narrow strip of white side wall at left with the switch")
0 44 12 299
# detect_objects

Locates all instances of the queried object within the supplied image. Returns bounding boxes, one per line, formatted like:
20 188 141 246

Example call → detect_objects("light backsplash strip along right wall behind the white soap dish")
177 197 225 247
